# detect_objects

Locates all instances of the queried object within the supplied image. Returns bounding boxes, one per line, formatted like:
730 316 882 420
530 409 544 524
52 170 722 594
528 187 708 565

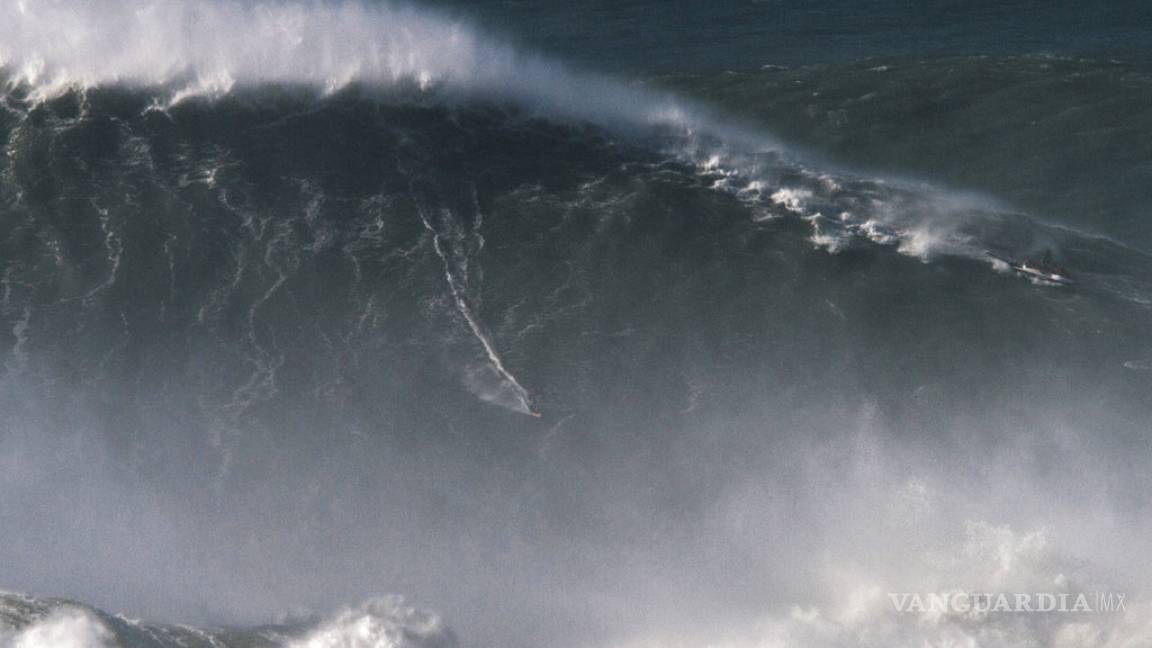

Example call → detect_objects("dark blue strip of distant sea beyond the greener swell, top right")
434 0 1152 75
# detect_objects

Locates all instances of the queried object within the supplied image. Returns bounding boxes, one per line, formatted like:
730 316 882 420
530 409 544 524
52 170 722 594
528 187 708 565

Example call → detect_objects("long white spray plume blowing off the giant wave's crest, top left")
0 0 691 125
